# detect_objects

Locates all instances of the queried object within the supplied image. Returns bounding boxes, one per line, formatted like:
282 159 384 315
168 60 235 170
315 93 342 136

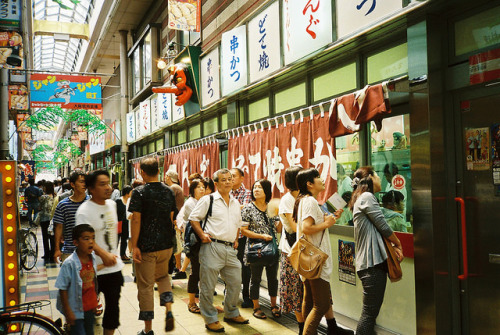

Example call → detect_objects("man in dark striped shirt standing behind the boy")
53 170 89 263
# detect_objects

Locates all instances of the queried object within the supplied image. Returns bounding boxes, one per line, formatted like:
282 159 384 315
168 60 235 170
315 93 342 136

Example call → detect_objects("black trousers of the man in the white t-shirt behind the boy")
97 271 123 329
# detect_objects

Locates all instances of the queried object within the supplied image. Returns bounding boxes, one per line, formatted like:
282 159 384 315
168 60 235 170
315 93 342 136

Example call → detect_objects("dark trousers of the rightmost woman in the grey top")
356 266 387 335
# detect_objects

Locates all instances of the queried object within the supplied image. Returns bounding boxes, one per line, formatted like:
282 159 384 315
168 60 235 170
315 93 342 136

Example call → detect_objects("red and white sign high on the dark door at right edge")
469 49 500 85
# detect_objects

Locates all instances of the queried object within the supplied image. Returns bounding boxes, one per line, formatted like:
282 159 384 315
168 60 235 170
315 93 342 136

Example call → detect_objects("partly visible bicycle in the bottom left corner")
0 300 64 335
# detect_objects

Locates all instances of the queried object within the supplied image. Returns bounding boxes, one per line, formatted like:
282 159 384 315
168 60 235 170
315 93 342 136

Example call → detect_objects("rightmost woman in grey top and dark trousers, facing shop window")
349 166 403 335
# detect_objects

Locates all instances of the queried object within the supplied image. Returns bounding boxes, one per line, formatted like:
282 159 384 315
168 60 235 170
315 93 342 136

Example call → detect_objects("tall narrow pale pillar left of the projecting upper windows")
120 30 130 186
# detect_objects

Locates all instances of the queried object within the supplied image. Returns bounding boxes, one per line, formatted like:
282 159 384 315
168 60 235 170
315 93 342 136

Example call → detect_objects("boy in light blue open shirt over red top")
55 224 97 335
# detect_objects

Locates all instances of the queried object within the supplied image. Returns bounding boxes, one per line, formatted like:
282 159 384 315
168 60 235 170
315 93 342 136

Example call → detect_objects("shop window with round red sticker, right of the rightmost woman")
371 114 413 232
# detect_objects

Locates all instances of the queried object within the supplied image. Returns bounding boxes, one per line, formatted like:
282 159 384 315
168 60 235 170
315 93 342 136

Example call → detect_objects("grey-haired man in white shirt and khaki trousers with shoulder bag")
189 169 248 332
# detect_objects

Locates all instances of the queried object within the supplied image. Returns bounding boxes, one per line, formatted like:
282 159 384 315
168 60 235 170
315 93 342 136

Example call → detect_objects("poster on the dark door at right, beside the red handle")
465 128 490 171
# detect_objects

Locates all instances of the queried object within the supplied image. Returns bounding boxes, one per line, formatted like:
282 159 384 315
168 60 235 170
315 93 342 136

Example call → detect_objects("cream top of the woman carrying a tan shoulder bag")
297 196 333 282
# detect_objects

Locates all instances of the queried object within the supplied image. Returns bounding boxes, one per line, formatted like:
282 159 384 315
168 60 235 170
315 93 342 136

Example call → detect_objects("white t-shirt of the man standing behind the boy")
76 199 124 276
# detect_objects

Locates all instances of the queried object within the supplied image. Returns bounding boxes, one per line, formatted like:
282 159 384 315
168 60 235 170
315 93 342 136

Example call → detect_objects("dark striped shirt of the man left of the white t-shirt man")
52 196 90 254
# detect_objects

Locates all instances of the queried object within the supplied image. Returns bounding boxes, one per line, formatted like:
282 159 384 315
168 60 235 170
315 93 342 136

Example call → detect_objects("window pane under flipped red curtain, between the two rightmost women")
335 133 360 226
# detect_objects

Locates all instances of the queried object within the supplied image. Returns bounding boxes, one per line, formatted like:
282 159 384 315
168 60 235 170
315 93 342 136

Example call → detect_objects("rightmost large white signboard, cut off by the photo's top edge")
336 0 403 38
